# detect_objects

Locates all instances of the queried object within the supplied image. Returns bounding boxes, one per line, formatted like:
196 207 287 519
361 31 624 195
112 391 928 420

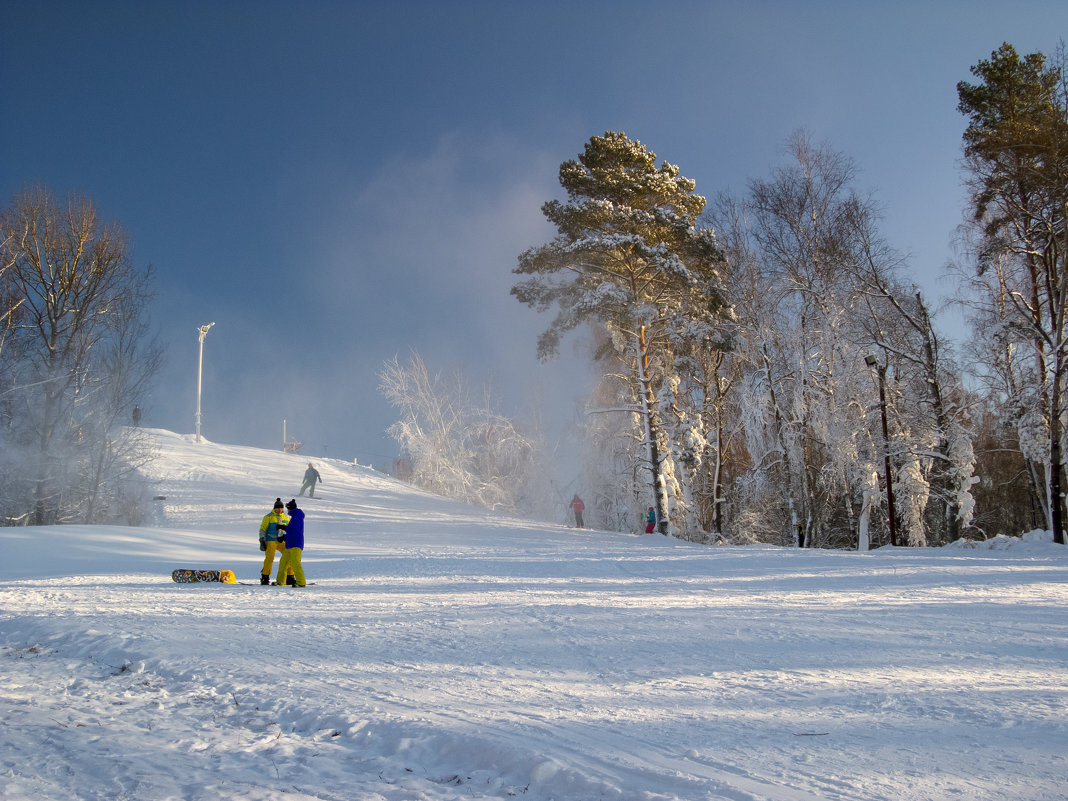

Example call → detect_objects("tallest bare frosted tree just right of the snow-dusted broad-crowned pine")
721 132 876 545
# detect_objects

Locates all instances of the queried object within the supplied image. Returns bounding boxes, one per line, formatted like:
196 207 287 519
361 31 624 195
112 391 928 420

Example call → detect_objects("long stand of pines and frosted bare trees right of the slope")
512 45 1068 548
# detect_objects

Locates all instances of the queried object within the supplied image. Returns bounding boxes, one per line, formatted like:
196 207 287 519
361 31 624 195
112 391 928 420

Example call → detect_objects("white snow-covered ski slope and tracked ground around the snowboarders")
0 431 1068 801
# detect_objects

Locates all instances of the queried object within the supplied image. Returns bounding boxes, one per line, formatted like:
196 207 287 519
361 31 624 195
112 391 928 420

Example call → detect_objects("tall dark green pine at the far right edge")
957 43 1068 543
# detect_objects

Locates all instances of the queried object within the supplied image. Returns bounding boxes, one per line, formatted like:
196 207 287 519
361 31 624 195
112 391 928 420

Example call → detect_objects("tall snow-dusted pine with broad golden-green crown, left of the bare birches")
512 131 731 533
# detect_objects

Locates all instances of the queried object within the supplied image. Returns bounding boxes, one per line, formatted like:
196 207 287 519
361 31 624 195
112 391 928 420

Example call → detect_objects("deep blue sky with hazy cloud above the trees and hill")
0 0 1068 474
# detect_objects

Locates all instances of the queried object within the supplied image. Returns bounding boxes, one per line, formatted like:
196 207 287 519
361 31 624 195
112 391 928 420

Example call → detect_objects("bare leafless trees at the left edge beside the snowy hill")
0 187 160 525
